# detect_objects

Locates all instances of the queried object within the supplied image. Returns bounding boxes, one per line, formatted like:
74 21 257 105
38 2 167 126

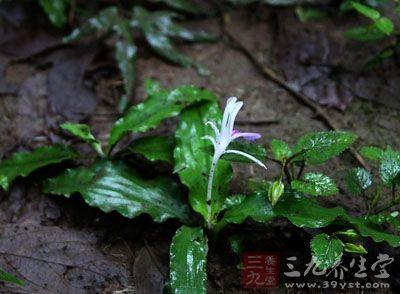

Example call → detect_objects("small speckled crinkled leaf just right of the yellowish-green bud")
291 173 338 196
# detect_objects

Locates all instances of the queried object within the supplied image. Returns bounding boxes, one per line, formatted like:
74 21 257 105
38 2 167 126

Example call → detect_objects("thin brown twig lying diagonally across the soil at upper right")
222 24 370 170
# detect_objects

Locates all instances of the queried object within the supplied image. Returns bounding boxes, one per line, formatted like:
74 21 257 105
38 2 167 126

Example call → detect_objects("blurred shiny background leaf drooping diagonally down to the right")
132 6 208 74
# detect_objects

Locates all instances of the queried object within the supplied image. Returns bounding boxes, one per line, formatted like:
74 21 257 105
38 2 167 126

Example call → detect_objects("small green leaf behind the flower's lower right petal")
221 140 267 163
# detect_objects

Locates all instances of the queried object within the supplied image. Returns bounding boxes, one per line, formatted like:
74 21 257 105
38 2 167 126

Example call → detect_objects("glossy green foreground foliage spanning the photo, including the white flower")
0 81 400 293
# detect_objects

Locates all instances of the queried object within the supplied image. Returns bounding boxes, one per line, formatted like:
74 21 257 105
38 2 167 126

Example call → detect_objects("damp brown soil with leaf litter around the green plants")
0 2 400 293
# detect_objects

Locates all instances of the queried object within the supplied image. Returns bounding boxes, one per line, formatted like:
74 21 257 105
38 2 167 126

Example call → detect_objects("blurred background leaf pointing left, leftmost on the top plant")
64 6 120 42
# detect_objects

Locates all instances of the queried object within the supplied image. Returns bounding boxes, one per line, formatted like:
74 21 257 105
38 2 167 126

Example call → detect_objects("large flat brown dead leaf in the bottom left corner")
0 225 128 294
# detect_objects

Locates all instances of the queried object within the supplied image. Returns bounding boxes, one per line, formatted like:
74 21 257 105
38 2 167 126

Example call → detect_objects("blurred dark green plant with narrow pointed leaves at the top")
39 0 217 112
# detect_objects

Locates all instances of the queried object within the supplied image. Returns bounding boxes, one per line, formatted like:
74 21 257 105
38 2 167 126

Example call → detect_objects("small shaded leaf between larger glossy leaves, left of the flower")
128 136 175 164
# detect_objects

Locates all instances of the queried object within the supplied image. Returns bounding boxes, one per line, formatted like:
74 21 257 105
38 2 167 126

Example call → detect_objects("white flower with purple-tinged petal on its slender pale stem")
204 97 267 225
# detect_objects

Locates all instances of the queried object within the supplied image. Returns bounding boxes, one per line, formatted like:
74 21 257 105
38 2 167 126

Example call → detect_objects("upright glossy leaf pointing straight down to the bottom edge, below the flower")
170 226 208 294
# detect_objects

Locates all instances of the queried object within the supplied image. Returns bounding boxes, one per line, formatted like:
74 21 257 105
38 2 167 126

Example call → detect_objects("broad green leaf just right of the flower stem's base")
222 193 275 224
